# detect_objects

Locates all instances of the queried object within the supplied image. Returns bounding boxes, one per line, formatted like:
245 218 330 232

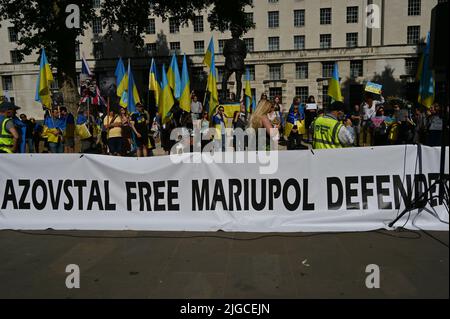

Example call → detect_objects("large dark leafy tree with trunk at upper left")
0 0 254 112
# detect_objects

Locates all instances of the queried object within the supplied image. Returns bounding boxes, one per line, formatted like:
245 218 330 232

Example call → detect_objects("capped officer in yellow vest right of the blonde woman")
312 101 355 149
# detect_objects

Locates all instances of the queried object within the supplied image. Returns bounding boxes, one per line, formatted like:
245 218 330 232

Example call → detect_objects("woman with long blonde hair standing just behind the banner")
250 100 279 150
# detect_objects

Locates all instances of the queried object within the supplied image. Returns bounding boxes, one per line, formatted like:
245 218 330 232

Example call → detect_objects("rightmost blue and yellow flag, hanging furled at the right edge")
417 32 435 108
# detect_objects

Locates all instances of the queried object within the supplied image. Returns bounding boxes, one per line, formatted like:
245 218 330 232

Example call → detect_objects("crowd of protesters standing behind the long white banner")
0 92 443 157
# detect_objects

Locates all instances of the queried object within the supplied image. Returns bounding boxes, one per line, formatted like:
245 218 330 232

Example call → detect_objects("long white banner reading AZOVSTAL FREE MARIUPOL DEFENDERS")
0 145 449 232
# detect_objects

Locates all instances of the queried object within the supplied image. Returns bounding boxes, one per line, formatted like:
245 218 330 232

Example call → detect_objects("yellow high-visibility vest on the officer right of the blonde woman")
313 116 343 149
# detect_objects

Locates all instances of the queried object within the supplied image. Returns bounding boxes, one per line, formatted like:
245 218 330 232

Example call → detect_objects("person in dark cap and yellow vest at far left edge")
0 102 20 153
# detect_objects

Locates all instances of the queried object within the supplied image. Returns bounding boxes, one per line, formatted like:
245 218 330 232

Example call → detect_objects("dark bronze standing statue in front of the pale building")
222 27 247 102
